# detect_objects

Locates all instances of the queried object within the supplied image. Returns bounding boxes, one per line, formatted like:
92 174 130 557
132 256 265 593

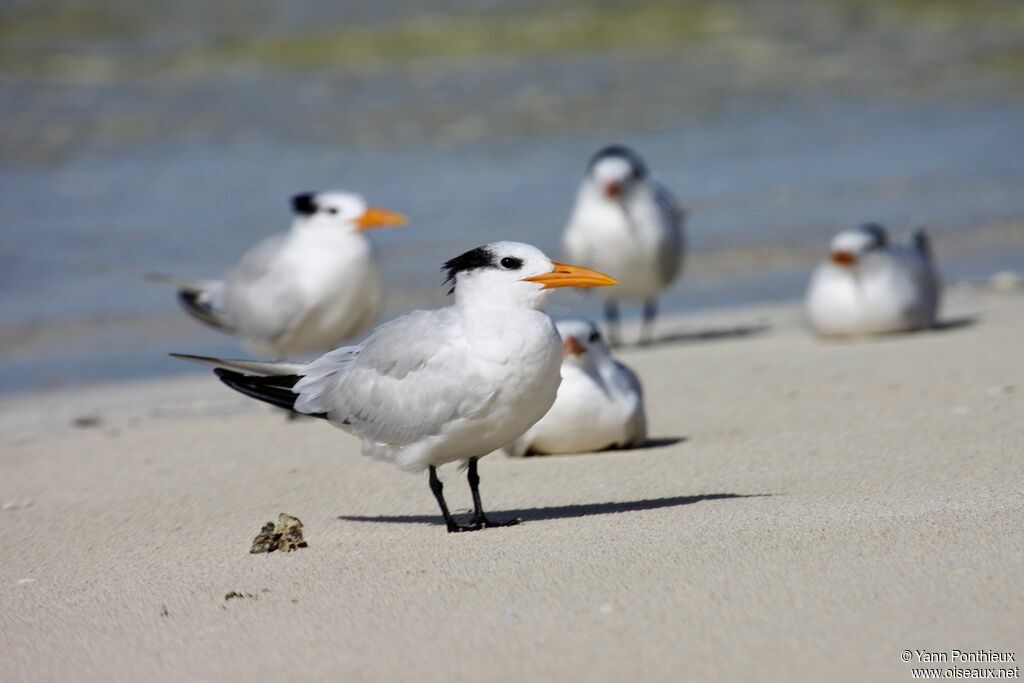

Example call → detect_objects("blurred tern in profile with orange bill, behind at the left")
150 193 406 358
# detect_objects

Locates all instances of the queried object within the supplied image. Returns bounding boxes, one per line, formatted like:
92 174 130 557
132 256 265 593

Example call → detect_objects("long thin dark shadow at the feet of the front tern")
338 494 772 526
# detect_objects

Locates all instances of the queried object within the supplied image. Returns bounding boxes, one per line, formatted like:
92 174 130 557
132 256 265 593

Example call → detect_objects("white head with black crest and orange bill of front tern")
441 242 616 309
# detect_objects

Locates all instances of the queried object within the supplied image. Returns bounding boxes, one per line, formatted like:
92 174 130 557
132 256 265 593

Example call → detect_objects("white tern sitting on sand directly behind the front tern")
505 318 647 457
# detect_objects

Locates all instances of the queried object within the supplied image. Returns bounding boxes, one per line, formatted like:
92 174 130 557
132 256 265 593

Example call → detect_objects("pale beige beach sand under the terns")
0 288 1024 681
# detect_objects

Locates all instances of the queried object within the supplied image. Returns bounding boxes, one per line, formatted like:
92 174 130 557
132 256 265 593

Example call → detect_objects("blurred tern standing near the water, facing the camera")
562 144 686 345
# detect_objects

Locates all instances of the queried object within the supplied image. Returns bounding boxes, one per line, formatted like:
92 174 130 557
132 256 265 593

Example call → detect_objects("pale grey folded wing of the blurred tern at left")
223 234 304 342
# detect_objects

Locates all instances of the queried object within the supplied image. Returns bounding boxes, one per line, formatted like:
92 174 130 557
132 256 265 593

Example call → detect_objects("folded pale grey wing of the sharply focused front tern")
295 309 494 445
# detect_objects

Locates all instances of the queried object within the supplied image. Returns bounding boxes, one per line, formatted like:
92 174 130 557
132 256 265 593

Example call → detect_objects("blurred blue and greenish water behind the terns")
0 0 1024 391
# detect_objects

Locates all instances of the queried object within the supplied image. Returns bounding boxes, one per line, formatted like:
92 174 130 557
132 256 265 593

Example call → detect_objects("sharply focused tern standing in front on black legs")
179 242 615 531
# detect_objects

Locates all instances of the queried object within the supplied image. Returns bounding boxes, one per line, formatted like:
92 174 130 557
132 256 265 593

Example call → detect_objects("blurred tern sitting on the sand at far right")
805 224 942 336
